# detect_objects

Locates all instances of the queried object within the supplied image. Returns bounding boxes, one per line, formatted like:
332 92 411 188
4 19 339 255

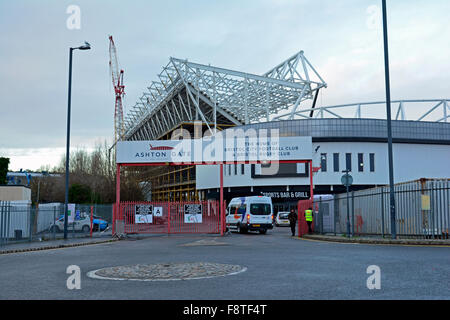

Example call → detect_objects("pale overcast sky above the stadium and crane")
0 0 450 170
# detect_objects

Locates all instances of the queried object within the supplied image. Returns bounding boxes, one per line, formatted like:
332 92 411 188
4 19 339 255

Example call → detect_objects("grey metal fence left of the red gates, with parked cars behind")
0 201 112 246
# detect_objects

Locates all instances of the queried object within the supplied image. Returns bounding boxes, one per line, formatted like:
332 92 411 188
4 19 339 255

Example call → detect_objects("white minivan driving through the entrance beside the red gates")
226 196 273 234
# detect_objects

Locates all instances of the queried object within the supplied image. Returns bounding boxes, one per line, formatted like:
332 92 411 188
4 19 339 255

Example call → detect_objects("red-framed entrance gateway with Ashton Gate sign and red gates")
113 135 313 235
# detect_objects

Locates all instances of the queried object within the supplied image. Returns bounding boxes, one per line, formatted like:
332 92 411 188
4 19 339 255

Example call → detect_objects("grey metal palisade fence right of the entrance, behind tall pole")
314 179 450 239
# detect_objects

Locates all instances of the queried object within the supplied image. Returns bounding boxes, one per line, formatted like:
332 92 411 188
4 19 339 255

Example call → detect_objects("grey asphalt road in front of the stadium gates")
0 228 450 300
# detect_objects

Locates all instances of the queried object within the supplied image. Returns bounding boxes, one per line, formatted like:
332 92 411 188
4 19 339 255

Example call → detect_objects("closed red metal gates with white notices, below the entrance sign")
113 201 223 234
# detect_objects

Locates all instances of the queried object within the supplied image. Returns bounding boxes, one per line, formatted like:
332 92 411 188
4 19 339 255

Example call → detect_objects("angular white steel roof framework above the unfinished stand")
124 51 327 140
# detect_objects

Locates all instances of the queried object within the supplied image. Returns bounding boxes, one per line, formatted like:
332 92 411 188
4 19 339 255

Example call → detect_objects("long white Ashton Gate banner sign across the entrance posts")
116 136 312 164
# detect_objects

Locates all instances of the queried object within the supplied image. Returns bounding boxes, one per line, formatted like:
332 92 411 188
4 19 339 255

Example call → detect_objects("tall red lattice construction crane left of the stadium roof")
109 36 125 142
